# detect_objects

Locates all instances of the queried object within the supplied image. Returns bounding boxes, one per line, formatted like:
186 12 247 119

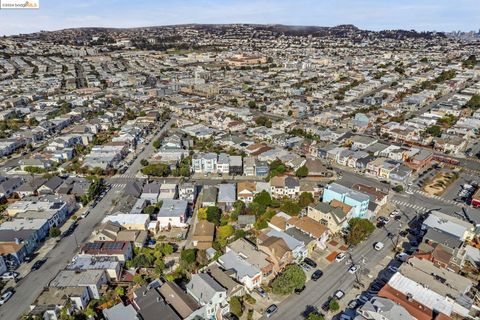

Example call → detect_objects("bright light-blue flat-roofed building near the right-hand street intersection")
322 183 370 218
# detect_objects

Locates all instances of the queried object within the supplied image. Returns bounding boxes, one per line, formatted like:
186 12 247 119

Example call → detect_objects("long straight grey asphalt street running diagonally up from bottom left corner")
0 119 174 320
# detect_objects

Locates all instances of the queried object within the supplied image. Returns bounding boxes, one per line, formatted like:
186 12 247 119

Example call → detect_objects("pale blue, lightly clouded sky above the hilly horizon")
0 0 480 35
